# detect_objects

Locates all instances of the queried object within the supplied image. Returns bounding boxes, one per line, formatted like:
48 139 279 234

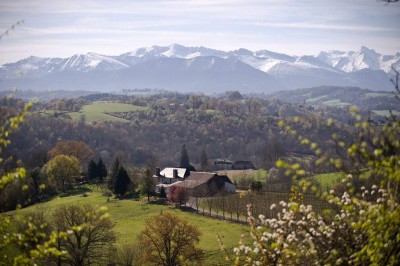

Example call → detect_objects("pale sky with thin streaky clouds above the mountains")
0 0 400 64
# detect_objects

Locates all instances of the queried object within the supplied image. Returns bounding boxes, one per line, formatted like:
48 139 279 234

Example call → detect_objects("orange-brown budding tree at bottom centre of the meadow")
141 212 203 266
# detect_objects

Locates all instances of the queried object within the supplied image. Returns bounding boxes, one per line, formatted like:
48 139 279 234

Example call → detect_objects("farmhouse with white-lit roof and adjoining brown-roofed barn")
154 168 236 197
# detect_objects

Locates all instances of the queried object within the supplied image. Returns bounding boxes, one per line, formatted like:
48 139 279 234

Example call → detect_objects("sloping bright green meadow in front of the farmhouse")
10 188 247 265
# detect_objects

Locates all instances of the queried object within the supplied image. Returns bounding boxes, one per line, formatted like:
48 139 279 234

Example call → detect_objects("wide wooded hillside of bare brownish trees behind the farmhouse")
1 92 351 171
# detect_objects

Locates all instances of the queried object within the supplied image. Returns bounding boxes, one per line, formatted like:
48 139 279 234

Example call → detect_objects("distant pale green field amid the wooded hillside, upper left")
40 102 147 123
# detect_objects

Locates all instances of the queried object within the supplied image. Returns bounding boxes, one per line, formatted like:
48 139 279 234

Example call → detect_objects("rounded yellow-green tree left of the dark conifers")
46 155 81 192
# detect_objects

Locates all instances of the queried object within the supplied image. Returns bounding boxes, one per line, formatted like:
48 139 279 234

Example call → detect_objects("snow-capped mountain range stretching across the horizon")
0 44 400 93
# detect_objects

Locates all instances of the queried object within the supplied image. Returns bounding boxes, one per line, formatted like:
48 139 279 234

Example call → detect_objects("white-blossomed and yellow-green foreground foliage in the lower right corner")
225 109 400 265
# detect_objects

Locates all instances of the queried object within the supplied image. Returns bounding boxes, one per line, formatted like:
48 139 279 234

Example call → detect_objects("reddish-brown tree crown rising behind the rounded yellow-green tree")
49 140 94 167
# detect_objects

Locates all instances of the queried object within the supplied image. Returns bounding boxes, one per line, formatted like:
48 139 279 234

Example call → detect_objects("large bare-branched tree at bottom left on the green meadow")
53 205 115 266
